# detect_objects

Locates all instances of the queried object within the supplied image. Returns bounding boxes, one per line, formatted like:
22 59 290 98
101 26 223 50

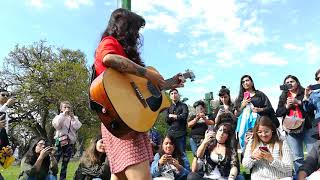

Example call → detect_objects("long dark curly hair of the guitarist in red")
101 8 146 66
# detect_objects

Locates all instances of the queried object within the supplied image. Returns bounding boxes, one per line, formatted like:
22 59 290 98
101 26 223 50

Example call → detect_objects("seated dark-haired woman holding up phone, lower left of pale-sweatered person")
18 138 58 180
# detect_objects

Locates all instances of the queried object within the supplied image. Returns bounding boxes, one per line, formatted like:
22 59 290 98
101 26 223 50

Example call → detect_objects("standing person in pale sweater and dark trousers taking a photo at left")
52 101 82 180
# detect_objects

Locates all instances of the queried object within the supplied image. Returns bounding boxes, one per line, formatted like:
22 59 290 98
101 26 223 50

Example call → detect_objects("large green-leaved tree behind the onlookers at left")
0 41 98 150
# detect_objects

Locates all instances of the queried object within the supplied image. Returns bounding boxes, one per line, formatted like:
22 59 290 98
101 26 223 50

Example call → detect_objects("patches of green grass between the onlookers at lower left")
0 161 79 180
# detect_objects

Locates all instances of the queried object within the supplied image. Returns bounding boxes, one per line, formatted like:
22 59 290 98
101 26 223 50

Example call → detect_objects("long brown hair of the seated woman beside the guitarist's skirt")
80 135 106 166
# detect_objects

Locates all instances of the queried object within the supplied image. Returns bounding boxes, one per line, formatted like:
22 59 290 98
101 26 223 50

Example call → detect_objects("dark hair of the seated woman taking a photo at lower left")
25 137 50 172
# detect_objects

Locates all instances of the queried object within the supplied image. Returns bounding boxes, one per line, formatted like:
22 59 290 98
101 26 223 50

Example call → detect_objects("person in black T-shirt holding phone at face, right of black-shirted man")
188 100 214 154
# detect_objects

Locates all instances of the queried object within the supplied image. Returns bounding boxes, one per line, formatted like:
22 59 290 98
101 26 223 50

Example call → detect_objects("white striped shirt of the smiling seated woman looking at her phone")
242 140 293 180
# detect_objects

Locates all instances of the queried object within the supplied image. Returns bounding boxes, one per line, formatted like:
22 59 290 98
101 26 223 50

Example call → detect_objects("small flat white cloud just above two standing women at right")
250 52 288 65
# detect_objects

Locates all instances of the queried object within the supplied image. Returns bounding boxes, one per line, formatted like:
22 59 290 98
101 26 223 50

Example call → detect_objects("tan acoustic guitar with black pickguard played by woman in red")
90 67 195 139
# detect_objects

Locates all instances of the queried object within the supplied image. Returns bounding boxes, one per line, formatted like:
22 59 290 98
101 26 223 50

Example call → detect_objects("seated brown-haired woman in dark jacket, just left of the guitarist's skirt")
73 135 111 180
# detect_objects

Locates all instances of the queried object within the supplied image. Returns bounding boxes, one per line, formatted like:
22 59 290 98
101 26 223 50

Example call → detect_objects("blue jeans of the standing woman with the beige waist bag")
287 128 317 173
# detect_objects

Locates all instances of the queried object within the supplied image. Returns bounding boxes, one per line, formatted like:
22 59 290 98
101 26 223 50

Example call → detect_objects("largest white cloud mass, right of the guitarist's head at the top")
132 0 266 55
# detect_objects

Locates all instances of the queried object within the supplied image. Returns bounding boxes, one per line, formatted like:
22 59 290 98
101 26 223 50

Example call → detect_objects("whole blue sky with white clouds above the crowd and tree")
0 0 320 108
